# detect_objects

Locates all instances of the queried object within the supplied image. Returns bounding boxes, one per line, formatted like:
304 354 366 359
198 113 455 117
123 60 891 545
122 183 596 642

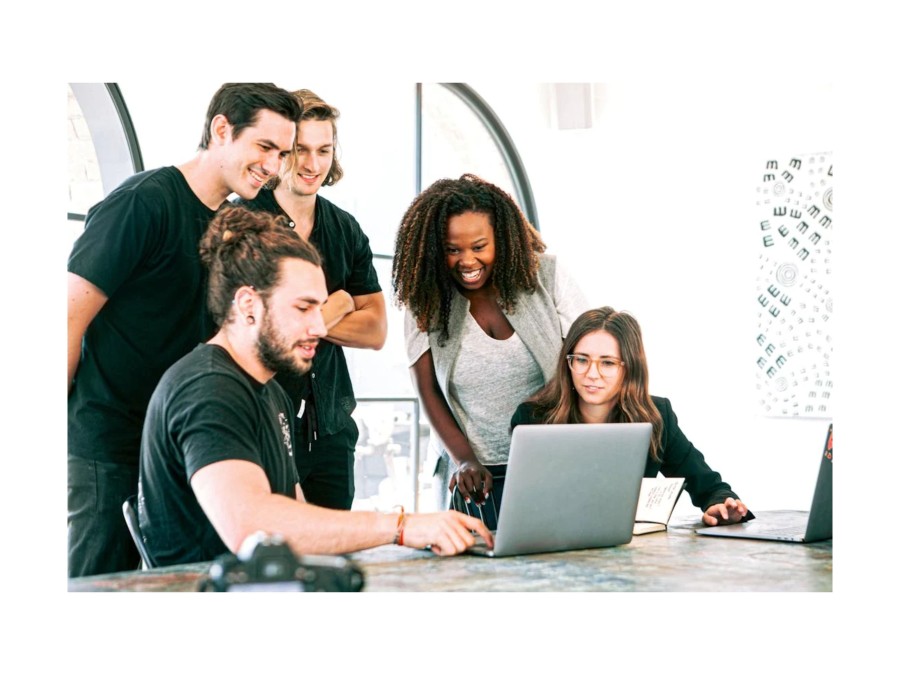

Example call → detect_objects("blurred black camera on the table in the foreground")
200 533 363 592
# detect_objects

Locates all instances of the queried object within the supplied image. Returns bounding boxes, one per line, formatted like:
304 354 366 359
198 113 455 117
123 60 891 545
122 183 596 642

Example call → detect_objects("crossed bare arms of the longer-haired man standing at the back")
322 291 387 349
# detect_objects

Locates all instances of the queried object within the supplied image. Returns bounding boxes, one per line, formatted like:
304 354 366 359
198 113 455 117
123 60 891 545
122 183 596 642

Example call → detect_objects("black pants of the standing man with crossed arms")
294 419 359 511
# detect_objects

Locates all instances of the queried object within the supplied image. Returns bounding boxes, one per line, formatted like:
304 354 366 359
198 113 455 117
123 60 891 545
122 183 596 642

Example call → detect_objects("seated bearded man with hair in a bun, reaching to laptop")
138 207 493 565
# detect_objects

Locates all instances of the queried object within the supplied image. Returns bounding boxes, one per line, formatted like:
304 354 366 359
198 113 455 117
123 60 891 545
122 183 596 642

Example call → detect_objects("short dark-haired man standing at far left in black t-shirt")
68 84 301 577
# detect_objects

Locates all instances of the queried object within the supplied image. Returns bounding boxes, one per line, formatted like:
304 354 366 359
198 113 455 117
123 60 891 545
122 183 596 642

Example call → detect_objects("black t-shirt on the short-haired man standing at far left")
68 167 215 465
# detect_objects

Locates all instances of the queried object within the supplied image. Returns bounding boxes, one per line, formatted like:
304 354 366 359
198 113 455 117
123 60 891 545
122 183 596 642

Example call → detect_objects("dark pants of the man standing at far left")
68 455 141 577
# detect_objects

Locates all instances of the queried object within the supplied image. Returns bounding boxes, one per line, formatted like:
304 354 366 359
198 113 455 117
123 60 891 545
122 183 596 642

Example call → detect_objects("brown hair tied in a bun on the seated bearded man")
200 205 322 326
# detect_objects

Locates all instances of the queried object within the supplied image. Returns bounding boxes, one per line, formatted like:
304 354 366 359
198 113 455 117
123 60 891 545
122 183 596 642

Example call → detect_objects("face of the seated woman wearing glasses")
570 330 625 422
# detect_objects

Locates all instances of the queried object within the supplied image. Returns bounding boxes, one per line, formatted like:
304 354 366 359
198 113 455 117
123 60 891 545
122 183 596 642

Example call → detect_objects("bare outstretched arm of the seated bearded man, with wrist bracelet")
191 460 493 555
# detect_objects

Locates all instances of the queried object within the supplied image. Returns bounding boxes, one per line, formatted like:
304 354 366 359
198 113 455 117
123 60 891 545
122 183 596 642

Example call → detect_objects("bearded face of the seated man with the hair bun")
257 258 328 375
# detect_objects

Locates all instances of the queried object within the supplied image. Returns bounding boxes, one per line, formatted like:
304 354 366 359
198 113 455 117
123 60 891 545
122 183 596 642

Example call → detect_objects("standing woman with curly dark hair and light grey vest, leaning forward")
392 174 587 508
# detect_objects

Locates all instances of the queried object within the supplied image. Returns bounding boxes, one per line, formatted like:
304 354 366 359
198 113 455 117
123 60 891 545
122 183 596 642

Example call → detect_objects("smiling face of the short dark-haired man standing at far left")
213 110 296 199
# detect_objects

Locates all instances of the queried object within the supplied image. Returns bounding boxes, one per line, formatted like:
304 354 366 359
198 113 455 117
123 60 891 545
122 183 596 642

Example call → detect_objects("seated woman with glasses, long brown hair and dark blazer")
511 307 753 525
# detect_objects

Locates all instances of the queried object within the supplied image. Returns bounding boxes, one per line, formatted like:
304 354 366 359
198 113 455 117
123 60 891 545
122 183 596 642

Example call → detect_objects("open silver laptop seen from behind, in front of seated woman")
469 423 651 557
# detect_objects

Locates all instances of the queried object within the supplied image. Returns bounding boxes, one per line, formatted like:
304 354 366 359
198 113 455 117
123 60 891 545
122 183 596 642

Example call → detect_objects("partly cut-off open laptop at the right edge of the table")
695 424 833 543
